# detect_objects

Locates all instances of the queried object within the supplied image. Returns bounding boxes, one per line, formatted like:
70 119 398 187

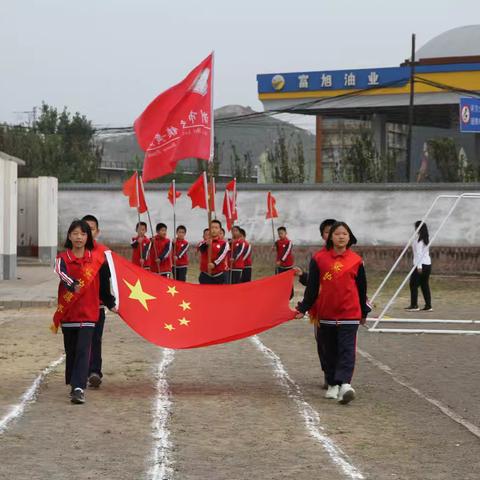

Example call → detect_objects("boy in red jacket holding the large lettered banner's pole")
198 220 229 285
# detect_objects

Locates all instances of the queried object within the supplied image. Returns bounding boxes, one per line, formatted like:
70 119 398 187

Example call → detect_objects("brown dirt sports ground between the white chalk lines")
0 268 480 480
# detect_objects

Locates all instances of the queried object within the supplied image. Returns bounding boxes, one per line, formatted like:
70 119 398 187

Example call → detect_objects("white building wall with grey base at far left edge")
0 158 18 280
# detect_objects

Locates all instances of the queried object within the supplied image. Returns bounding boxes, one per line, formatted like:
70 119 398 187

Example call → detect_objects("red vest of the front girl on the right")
309 248 362 321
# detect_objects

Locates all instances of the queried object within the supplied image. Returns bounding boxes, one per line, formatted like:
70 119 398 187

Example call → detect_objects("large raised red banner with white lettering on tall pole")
134 54 213 182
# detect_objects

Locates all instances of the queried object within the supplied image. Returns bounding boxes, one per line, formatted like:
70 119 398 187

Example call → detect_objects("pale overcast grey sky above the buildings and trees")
0 0 480 126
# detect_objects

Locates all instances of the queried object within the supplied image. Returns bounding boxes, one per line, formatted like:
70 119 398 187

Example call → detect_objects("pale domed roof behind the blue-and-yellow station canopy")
415 25 480 60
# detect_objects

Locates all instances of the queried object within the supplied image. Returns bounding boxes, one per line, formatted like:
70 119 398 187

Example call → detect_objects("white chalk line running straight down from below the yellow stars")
149 348 175 480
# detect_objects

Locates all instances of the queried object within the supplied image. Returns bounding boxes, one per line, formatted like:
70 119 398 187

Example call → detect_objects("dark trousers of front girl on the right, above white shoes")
319 323 358 385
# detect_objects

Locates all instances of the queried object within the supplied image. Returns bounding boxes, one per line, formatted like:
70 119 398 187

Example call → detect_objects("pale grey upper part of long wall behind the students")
59 184 480 246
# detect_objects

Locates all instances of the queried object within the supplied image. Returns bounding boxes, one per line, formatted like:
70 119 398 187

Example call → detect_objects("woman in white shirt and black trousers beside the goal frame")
405 221 433 312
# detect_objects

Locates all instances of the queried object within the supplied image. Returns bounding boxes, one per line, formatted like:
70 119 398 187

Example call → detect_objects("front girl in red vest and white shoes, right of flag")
296 222 370 404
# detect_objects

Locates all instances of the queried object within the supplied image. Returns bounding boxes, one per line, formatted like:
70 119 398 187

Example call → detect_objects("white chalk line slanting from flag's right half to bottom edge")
250 337 365 479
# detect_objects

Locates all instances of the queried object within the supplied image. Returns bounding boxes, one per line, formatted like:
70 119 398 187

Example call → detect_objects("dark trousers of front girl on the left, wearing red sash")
62 327 94 389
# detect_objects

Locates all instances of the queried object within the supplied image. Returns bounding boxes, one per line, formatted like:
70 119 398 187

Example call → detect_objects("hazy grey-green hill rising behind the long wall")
98 105 315 181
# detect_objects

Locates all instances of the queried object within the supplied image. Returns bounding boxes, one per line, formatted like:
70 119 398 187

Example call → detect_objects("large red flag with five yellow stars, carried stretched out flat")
106 251 296 349
